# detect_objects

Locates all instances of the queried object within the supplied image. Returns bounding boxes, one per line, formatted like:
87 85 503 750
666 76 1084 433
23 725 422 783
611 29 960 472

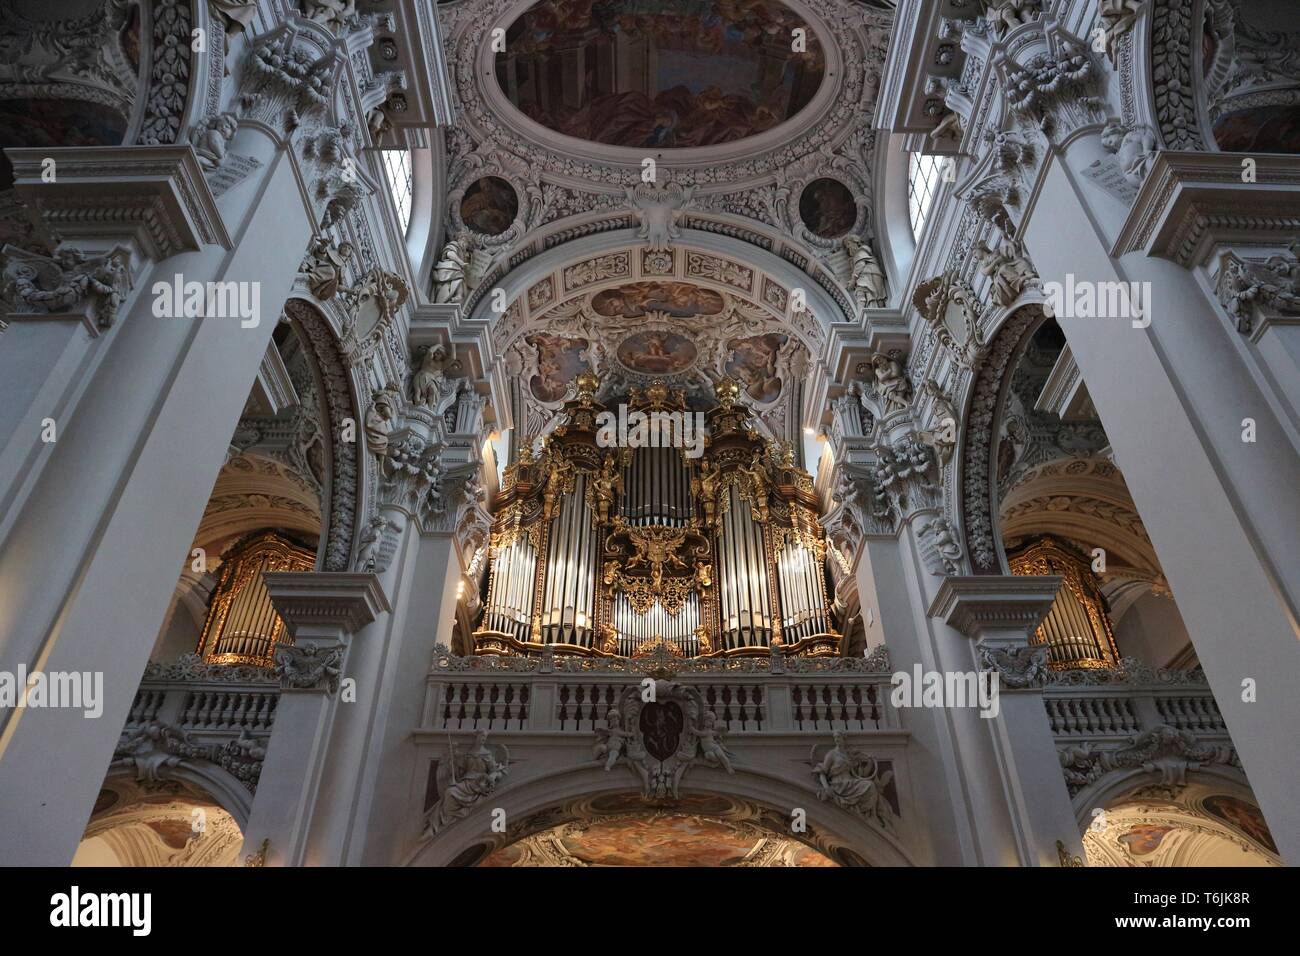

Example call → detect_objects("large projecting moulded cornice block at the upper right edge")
1112 151 1300 269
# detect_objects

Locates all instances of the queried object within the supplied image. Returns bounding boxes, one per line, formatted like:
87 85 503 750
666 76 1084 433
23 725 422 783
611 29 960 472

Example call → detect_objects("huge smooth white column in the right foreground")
1023 143 1300 861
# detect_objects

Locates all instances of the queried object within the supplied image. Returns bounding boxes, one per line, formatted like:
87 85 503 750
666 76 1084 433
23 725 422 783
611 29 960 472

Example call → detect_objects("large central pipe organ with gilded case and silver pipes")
473 372 840 657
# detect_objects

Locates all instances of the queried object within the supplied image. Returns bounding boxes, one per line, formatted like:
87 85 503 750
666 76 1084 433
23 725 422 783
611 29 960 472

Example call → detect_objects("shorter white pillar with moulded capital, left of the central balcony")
244 572 390 866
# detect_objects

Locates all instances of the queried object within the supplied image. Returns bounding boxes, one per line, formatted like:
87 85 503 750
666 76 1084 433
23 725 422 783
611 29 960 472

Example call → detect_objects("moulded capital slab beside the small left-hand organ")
264 571 393 644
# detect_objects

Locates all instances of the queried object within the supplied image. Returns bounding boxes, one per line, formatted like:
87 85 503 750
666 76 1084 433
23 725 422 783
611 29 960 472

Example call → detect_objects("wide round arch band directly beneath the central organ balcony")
403 765 915 866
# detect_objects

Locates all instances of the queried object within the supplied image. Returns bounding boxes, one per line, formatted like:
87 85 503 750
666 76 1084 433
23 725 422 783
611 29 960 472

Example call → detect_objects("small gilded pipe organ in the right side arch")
1006 536 1119 669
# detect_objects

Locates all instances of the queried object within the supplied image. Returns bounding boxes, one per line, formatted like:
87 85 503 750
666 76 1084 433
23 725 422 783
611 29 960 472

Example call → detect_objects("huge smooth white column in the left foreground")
0 129 312 865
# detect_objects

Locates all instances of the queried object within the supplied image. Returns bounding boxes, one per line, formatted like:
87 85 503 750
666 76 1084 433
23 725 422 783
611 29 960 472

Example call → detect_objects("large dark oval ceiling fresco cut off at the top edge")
497 0 826 148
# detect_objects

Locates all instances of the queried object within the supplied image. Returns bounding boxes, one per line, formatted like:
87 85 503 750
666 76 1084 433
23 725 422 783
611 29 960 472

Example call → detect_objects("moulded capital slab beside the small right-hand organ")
928 575 1061 643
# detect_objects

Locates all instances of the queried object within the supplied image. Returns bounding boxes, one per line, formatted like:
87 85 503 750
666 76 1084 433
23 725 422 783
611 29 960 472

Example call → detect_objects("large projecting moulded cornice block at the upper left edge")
5 146 231 260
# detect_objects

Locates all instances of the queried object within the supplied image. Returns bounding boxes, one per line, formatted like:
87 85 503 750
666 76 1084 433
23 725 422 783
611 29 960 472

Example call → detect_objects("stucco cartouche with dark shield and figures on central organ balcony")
593 680 735 800
